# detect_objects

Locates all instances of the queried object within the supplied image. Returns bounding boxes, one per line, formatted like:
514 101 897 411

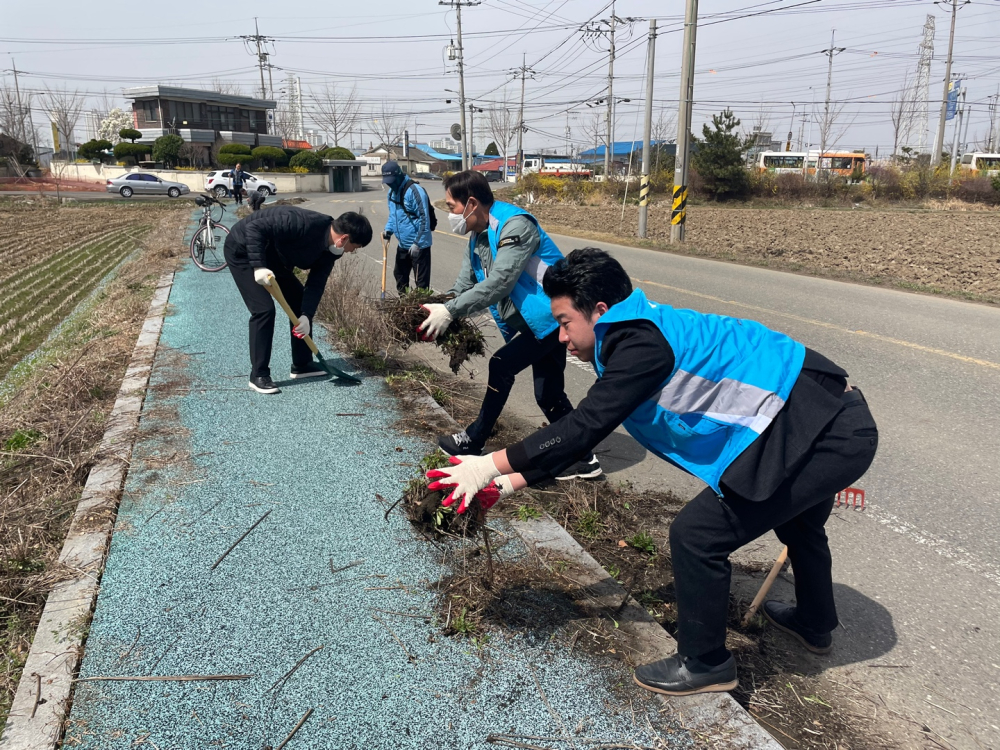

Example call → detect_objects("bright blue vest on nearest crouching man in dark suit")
594 289 806 496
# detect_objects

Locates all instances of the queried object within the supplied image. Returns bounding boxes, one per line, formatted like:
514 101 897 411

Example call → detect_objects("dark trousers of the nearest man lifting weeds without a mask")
670 390 878 656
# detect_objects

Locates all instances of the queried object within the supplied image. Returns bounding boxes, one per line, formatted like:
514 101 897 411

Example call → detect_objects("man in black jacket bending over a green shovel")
225 206 372 393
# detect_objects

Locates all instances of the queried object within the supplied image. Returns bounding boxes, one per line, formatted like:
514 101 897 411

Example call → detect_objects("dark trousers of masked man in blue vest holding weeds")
466 330 573 447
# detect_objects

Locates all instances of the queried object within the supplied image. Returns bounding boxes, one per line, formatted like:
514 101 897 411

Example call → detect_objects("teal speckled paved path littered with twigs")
67 213 687 750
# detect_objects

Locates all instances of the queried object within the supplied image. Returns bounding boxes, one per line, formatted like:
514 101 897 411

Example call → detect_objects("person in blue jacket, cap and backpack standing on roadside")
382 161 437 294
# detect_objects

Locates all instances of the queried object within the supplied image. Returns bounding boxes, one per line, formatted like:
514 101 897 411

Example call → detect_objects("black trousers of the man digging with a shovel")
225 251 312 378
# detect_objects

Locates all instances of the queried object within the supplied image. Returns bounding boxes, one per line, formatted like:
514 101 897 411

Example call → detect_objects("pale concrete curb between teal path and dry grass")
0 271 174 750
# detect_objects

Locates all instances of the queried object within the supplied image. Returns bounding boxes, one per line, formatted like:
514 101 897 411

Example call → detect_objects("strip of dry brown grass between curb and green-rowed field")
0 207 189 726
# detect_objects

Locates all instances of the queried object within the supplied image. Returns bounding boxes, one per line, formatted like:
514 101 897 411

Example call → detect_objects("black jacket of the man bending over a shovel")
226 206 337 319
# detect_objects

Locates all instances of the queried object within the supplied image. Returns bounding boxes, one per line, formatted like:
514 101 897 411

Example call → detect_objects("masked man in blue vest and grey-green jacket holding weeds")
420 171 601 479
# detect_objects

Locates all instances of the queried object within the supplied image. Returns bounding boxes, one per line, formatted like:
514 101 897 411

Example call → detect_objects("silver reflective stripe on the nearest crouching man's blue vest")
652 370 785 433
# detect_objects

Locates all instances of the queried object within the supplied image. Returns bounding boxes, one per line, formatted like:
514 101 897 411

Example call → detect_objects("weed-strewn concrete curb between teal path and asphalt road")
411 396 781 750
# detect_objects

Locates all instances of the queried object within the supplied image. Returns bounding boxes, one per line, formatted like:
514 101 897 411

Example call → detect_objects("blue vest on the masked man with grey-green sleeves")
469 201 563 341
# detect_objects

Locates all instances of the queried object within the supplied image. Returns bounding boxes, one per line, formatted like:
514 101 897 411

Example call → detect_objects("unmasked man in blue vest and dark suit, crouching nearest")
428 248 878 695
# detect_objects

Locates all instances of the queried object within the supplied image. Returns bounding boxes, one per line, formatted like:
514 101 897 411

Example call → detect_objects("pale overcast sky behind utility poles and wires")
0 0 1000 153
